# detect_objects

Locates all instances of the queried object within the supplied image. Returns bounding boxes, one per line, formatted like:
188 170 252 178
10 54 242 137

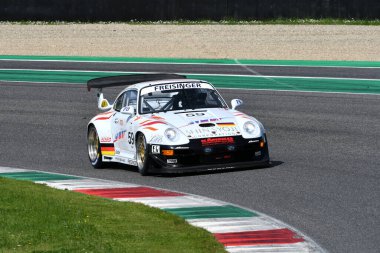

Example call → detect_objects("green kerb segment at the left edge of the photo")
0 171 81 181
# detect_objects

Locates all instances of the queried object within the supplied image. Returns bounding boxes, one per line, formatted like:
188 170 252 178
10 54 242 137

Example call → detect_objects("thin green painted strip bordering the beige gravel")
0 55 380 68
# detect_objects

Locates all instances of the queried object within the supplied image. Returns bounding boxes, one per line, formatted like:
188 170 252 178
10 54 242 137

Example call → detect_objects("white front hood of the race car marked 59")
157 108 241 139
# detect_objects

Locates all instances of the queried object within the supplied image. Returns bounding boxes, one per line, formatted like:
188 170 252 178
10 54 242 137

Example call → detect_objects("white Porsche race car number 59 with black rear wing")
87 74 269 175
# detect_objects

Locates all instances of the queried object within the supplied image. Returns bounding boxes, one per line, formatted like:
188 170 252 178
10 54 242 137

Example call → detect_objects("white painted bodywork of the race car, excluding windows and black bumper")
88 79 265 169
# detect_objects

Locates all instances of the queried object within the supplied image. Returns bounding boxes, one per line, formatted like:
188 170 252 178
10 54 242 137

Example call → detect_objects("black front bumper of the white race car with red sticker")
148 136 269 173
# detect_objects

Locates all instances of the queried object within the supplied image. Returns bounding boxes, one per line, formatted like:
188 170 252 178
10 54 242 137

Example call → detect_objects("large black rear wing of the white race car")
87 74 186 91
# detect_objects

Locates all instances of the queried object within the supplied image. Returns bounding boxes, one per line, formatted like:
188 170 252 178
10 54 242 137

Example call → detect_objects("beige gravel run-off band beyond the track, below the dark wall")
0 23 380 61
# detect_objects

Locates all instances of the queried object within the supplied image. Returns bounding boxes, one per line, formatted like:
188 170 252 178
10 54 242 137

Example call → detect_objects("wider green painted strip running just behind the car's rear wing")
0 70 380 94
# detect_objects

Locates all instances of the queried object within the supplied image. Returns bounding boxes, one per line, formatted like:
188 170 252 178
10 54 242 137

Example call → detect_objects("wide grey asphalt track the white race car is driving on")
0 62 380 252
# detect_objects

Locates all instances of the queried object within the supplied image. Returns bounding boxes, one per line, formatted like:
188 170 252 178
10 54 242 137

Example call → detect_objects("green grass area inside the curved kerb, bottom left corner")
0 178 225 253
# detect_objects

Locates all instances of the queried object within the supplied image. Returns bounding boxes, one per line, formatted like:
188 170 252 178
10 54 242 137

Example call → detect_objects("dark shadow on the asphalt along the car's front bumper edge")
156 161 284 177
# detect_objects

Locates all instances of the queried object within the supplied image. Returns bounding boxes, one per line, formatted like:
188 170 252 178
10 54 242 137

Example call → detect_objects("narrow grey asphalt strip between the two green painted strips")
0 60 380 79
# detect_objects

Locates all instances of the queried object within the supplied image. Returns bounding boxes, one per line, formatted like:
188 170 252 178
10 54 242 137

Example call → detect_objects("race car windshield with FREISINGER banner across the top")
139 83 227 114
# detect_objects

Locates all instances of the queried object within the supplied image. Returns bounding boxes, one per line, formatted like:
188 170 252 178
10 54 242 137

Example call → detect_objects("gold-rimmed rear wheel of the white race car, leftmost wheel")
87 126 103 169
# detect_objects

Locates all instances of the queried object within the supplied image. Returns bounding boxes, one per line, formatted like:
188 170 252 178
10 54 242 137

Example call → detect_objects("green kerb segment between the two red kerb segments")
163 205 258 219
